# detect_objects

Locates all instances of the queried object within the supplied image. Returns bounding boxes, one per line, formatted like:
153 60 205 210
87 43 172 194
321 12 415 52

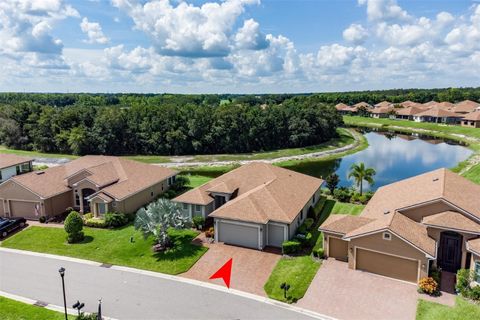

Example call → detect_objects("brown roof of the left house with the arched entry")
12 156 176 200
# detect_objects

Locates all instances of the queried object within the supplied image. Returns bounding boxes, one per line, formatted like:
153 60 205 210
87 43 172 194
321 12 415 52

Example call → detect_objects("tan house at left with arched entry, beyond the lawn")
0 156 177 220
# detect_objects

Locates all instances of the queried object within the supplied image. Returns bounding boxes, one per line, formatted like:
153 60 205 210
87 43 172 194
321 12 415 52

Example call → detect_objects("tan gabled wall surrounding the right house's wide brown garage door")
348 232 428 278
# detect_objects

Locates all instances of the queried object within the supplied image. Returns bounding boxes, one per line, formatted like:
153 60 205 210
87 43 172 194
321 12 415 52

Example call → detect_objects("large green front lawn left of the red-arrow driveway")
1 226 208 274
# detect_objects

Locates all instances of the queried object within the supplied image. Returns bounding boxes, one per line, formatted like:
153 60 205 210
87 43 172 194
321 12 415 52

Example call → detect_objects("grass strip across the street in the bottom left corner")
0 297 68 320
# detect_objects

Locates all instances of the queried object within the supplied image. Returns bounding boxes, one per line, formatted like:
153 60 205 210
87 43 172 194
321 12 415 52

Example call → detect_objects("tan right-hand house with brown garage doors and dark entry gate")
319 169 480 283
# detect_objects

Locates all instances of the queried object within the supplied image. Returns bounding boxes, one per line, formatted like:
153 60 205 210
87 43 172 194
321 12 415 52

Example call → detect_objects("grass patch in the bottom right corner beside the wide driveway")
416 297 480 320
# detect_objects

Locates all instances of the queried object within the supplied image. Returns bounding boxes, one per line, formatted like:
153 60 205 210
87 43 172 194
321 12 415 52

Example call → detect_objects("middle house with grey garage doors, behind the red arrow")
173 162 323 250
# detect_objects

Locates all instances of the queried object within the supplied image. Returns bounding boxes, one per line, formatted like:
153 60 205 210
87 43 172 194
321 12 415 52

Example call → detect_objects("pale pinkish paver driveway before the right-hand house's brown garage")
297 259 455 320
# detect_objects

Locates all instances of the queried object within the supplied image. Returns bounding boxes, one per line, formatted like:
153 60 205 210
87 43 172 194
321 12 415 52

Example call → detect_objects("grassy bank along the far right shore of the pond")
343 116 480 184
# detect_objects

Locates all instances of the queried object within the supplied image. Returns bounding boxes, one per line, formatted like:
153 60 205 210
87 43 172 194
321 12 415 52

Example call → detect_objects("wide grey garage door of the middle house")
218 221 259 249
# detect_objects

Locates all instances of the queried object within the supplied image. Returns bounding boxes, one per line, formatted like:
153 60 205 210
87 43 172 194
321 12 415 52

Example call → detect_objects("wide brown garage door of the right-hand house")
356 249 418 282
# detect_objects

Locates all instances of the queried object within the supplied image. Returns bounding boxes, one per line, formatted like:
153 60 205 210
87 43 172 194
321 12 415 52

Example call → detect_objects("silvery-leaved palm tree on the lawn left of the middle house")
134 199 188 249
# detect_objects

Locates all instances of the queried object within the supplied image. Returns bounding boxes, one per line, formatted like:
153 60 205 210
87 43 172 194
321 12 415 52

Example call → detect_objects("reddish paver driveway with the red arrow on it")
181 236 281 296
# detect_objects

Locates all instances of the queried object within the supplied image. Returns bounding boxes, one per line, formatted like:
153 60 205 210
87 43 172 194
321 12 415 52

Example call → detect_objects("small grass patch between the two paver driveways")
263 256 321 302
